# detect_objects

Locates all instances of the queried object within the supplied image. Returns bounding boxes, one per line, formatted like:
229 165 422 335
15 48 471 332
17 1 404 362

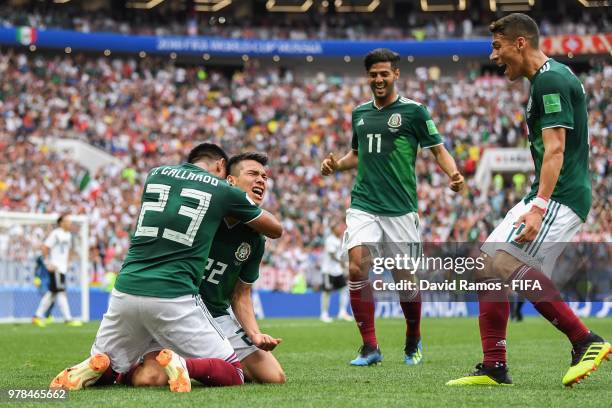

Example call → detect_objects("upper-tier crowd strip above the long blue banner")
0 4 611 40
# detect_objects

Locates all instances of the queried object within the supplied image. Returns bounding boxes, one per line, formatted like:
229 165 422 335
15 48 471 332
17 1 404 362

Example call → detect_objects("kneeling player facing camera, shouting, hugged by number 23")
128 153 285 386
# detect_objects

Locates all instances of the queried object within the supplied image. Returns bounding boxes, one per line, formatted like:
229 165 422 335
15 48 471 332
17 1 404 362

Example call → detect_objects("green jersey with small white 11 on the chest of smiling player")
351 96 442 217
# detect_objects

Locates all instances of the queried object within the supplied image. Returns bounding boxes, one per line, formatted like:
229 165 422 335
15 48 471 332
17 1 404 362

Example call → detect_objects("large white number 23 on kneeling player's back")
134 184 212 246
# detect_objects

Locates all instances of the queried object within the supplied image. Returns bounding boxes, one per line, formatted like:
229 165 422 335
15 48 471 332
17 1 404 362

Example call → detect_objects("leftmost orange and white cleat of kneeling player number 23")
49 353 110 391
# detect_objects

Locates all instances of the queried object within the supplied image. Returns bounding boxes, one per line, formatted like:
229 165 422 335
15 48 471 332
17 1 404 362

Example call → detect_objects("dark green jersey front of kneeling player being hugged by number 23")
200 221 266 317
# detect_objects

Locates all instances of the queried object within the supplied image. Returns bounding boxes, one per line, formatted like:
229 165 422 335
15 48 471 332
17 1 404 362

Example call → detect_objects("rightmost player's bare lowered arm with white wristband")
514 127 565 243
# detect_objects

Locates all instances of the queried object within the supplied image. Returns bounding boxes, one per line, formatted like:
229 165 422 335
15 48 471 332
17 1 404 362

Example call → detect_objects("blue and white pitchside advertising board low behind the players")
0 287 612 322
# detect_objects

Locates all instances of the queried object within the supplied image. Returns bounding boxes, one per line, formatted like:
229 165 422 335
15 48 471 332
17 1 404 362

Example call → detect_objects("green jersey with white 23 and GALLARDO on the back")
115 163 262 298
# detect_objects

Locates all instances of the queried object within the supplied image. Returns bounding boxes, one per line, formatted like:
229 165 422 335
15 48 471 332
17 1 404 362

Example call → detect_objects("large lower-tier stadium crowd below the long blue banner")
0 51 612 290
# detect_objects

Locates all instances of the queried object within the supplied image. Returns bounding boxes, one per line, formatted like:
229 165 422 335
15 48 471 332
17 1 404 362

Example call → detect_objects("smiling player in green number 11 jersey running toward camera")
321 49 464 366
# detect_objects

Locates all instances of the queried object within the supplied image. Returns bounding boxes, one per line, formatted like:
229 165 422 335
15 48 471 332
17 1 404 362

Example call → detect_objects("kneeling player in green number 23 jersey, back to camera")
50 143 282 392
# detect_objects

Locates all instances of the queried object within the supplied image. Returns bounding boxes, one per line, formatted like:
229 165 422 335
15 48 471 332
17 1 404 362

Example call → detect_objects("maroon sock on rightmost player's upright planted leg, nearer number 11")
478 279 510 368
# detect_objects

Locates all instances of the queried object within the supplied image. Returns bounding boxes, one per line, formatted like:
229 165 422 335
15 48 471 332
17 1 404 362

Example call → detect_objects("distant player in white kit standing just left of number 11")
321 222 353 323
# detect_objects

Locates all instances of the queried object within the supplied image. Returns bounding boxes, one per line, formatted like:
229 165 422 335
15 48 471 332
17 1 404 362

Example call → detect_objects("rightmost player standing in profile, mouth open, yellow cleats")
447 13 610 386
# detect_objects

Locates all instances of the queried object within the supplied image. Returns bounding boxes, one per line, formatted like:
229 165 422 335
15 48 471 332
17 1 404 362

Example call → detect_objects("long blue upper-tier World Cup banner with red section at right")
0 27 612 57
